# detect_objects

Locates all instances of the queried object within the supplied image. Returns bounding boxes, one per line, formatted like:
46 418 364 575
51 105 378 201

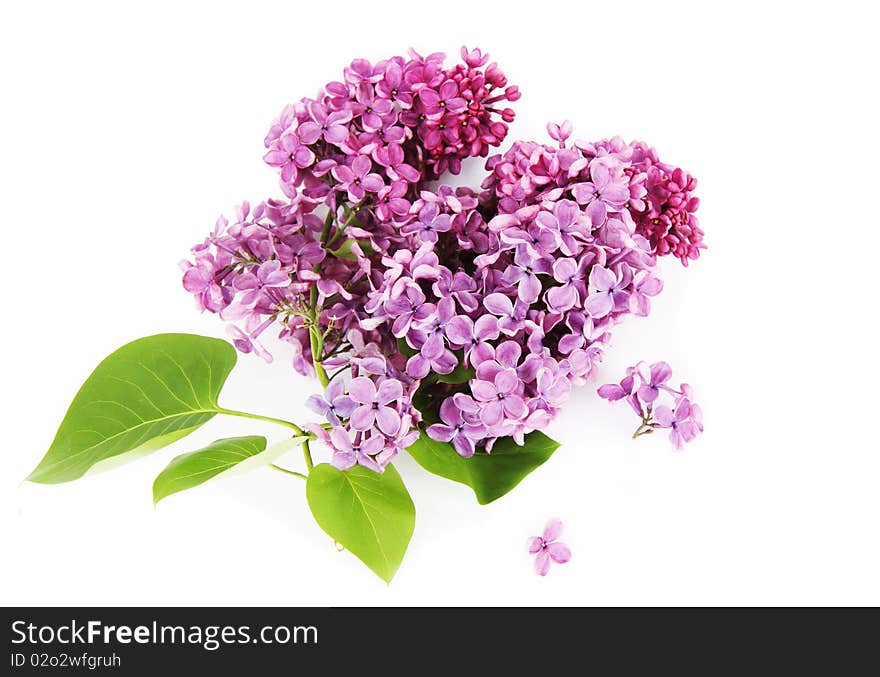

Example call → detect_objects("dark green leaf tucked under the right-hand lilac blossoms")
407 430 559 505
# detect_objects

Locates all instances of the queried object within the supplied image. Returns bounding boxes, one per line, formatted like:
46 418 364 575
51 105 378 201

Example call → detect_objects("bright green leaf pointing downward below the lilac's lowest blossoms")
306 463 416 583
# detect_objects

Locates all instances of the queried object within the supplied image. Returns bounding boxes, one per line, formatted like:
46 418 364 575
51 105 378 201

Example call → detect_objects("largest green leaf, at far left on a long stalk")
27 334 236 484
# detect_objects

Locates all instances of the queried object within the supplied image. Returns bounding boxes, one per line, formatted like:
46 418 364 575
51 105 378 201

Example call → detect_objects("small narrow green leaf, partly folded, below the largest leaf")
153 436 266 503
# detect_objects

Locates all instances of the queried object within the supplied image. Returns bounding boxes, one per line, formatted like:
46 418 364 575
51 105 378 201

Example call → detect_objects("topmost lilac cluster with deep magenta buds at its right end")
264 48 520 198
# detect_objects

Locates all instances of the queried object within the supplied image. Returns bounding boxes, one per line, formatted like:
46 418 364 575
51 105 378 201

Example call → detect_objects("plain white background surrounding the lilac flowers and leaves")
0 0 880 605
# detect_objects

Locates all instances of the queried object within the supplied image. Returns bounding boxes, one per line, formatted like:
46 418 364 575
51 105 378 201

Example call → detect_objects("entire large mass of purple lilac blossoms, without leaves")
183 49 704 471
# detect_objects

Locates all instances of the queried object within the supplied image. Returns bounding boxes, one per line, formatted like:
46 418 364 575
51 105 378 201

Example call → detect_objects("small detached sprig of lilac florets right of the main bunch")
599 362 703 449
